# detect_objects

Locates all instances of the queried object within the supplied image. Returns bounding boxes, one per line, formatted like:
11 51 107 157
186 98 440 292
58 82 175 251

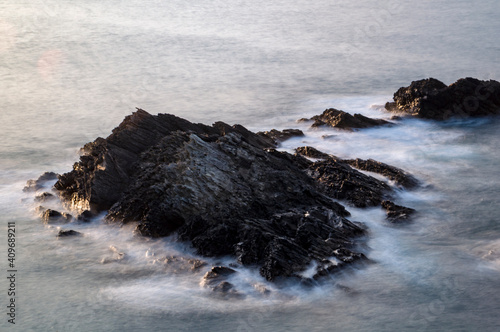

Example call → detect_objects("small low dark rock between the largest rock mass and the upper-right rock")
304 108 390 130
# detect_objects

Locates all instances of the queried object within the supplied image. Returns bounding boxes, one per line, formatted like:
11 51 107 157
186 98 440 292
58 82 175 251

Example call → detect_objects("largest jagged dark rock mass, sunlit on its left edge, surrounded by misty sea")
50 110 414 280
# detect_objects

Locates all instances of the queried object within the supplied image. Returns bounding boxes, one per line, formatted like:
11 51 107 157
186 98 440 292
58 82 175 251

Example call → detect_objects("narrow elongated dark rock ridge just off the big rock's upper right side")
344 158 419 188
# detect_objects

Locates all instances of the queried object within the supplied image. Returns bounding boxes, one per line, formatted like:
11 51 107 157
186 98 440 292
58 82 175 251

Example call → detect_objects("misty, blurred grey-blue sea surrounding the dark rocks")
0 0 500 332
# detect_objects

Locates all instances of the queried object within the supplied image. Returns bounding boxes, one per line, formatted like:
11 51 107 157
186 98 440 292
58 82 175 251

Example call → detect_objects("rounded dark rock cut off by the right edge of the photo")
385 77 500 120
